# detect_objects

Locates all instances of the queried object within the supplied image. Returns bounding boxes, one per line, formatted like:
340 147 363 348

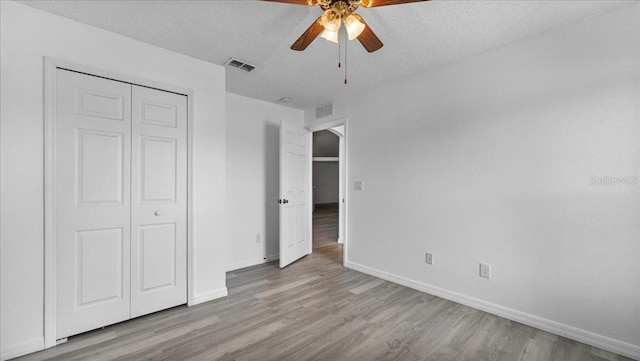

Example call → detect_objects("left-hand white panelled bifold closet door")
55 69 131 338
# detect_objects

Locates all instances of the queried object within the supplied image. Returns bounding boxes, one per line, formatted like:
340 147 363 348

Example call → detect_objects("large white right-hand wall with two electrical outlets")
305 2 640 358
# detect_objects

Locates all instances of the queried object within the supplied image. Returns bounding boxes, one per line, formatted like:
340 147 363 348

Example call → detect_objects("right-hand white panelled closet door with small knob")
131 85 187 317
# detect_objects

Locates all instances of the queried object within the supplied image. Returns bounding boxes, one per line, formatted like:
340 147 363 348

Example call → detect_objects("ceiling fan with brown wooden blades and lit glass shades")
263 0 429 53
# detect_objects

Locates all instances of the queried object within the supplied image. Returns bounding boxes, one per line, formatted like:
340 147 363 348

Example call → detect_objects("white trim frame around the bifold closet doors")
44 57 195 348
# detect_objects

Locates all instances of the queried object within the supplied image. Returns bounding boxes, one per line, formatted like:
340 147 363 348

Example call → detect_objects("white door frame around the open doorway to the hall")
306 117 349 267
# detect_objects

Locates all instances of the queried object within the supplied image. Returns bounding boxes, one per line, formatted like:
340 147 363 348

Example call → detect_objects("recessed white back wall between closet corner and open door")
226 93 304 270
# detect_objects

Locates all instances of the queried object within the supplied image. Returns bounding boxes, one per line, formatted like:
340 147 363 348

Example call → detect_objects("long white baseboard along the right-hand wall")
345 261 640 360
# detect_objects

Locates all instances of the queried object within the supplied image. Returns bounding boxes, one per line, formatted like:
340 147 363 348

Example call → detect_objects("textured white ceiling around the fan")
19 0 625 109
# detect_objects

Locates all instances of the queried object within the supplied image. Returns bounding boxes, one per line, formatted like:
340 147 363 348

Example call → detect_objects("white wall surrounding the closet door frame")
0 1 226 358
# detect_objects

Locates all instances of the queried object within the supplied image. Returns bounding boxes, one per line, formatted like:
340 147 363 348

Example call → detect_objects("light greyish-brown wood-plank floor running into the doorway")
17 204 629 361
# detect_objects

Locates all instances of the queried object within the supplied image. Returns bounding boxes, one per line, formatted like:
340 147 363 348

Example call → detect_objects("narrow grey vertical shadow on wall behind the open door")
262 122 280 260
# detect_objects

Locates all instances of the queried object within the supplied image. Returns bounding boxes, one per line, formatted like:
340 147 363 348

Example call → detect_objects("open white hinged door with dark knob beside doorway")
278 121 311 268
